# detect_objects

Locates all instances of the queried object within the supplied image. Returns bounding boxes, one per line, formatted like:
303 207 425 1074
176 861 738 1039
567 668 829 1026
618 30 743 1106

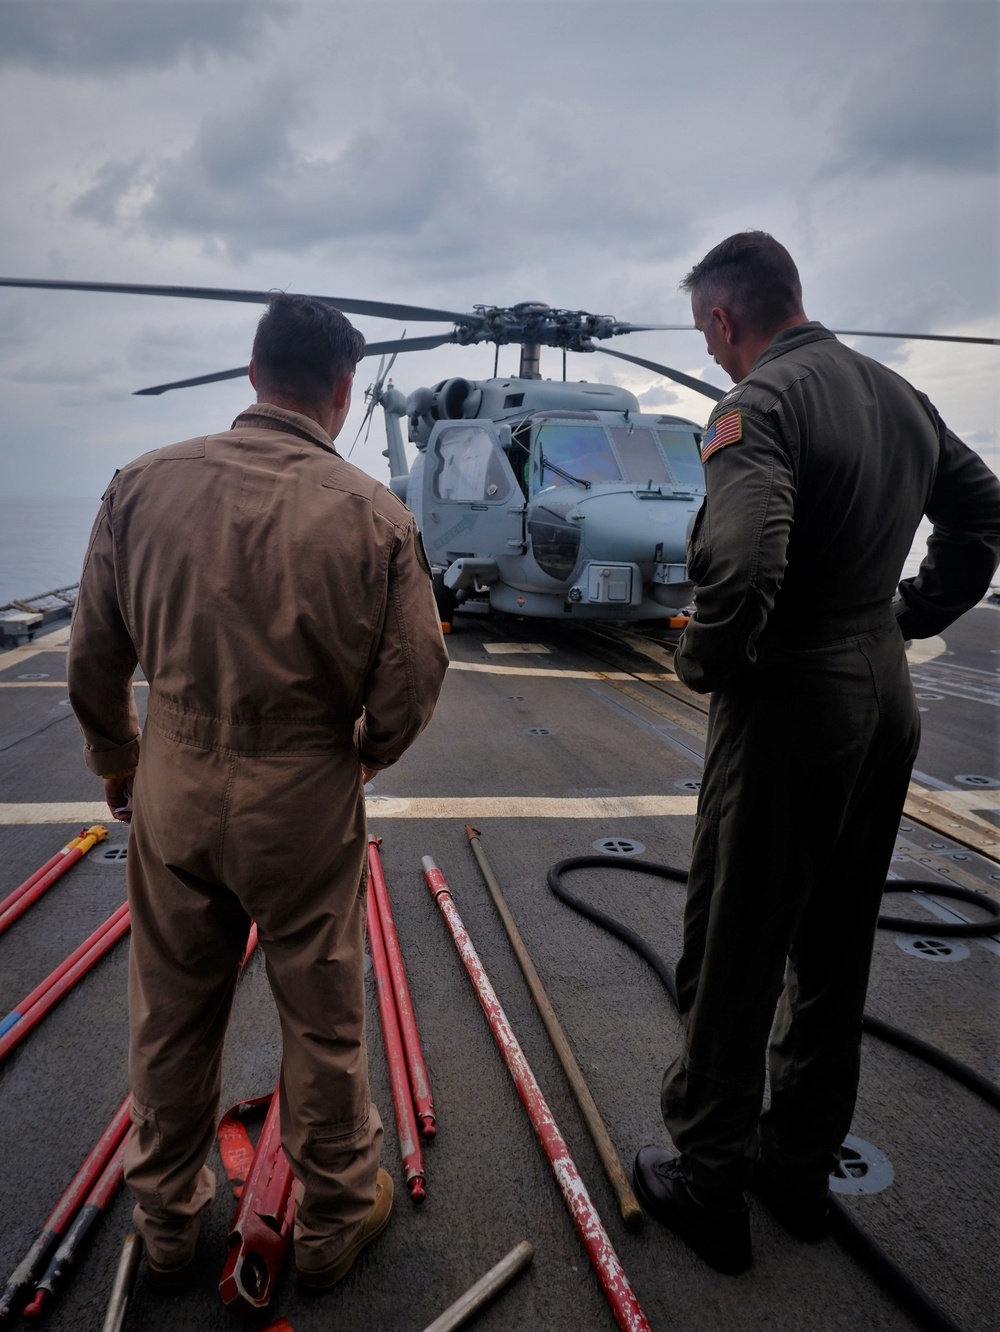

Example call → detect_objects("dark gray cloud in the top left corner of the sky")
0 0 290 77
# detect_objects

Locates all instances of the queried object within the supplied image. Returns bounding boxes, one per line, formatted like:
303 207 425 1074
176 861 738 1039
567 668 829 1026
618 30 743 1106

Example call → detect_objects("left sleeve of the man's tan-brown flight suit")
67 497 138 777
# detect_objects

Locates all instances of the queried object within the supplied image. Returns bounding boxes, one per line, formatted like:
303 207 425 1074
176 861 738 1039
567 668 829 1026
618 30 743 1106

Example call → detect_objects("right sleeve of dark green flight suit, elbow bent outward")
896 407 1000 638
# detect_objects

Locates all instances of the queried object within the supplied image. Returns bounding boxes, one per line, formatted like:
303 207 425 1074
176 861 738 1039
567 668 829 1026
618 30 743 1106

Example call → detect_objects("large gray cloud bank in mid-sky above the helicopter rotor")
73 71 696 277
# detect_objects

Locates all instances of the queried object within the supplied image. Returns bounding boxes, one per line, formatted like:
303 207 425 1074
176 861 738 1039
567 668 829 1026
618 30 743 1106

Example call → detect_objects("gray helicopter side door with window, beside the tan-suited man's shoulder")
423 421 525 569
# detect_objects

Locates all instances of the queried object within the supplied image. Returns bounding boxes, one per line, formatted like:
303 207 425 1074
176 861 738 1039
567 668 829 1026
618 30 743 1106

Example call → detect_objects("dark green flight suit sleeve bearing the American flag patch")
674 408 795 694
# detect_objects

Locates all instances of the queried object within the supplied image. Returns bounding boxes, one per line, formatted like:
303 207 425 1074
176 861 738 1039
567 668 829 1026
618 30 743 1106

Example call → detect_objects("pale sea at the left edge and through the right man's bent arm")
0 496 931 605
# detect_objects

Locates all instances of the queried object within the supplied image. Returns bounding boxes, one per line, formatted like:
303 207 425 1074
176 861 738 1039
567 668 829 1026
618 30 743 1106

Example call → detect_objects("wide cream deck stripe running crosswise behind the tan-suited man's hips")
0 795 698 826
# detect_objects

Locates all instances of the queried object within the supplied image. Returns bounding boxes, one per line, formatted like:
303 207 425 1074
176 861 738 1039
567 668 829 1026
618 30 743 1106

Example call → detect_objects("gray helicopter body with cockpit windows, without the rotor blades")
381 377 704 621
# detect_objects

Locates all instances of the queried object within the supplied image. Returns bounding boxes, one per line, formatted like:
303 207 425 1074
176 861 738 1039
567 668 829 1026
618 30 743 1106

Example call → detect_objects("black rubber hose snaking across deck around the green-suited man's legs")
547 855 1000 1332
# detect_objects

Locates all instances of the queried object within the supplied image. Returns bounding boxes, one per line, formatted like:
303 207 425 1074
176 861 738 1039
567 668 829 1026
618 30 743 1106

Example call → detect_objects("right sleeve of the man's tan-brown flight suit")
356 522 449 769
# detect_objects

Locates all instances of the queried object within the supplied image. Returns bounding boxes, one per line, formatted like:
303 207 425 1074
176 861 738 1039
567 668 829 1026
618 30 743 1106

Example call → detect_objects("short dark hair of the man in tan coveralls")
253 292 365 402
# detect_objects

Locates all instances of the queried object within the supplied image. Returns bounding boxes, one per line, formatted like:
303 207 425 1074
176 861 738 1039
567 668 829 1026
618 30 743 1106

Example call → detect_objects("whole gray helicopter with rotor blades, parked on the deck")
0 278 997 625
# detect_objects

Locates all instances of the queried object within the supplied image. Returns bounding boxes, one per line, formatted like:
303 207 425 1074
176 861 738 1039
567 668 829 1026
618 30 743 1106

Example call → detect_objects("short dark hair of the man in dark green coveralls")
680 232 802 332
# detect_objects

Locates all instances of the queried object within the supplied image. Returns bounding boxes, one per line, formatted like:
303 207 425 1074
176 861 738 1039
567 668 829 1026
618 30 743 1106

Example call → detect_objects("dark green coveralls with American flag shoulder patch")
662 322 1000 1199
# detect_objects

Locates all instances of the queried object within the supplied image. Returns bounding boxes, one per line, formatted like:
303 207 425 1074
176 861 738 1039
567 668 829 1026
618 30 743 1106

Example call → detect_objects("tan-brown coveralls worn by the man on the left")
68 404 447 1269
